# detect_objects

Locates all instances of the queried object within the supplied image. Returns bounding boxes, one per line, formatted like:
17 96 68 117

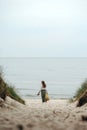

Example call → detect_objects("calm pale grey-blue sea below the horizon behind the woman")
0 58 87 98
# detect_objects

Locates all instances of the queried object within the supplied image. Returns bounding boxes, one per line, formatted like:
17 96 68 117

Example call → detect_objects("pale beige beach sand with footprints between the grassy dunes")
0 97 87 130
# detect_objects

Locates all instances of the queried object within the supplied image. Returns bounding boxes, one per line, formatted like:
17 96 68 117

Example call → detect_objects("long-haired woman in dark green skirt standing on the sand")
37 81 47 102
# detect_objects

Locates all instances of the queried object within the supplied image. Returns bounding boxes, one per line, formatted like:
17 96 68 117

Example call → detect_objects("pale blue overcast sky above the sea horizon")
0 0 87 57
